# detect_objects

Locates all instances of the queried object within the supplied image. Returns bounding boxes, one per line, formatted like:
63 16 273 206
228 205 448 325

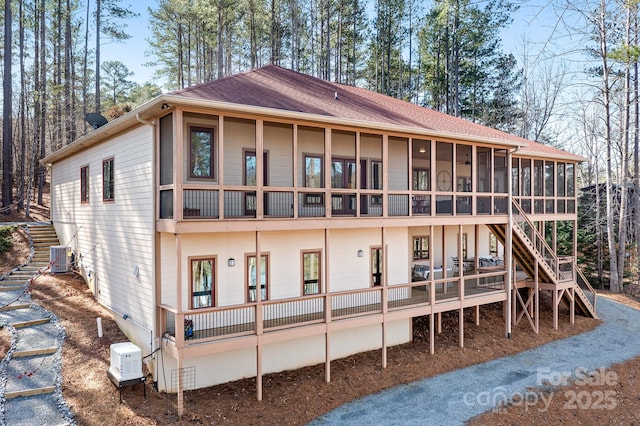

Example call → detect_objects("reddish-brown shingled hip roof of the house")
170 65 584 161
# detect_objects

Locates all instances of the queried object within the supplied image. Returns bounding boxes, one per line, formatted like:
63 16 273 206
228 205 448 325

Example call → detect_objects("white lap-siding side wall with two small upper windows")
51 126 155 350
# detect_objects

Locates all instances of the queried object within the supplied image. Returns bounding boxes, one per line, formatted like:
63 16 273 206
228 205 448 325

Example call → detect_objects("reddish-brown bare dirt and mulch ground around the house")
0 204 640 426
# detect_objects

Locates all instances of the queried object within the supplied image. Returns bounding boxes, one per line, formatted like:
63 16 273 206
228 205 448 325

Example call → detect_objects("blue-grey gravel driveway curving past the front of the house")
310 297 640 426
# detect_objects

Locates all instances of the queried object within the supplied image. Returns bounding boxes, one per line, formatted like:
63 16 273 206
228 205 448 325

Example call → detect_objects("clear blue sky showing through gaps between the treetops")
101 0 576 84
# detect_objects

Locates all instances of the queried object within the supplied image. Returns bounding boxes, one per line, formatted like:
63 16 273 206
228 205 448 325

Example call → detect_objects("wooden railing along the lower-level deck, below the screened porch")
160 270 506 345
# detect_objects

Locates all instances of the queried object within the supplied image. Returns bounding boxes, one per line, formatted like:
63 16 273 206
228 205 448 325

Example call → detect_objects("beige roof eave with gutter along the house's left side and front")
41 94 528 165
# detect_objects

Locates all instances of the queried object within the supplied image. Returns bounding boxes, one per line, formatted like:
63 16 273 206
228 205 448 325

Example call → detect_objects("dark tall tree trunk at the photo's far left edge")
2 0 13 214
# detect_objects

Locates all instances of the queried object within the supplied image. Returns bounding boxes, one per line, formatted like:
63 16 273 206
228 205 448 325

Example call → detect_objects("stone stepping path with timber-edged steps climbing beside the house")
0 224 75 426
